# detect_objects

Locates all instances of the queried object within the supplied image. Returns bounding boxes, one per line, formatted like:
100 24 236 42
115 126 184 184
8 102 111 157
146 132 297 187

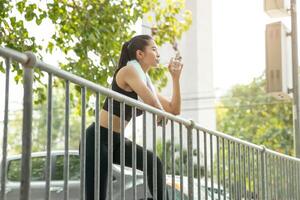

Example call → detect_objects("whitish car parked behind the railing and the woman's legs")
0 150 227 200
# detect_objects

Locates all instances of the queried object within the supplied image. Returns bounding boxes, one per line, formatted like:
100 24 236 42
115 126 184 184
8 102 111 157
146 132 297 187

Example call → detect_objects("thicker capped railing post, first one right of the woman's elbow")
187 120 195 199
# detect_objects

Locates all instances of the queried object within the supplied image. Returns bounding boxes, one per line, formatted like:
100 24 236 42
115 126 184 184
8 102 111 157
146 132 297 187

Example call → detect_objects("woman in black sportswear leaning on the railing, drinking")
86 35 183 200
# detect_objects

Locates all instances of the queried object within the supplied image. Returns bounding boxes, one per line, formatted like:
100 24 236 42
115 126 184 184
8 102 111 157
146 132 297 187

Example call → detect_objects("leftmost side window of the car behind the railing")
7 157 46 181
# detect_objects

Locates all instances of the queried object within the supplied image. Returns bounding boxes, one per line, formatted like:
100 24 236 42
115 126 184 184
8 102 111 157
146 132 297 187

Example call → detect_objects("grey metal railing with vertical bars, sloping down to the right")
0 48 300 200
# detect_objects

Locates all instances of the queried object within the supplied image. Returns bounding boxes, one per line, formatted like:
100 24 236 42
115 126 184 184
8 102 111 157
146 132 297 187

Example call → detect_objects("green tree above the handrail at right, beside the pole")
217 77 293 155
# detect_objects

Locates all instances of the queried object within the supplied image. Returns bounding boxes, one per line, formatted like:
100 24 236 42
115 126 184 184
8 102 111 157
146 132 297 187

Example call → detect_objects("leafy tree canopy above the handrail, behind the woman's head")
0 0 191 91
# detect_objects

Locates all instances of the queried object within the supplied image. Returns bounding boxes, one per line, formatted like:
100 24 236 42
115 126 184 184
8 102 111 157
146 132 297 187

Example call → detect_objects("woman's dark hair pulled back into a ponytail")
118 35 152 69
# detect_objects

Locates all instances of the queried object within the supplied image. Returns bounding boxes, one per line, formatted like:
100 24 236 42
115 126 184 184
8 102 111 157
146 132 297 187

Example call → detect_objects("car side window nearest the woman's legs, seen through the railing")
52 155 80 180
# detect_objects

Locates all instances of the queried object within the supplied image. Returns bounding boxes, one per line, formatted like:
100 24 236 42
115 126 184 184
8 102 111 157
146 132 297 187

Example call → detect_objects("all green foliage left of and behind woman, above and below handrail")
0 0 191 153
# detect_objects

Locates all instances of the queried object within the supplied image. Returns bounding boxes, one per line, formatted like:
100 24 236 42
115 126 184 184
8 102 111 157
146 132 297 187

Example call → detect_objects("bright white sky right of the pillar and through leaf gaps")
0 0 299 115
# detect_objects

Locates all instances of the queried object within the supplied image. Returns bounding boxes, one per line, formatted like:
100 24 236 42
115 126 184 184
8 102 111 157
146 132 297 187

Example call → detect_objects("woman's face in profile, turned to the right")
139 40 159 67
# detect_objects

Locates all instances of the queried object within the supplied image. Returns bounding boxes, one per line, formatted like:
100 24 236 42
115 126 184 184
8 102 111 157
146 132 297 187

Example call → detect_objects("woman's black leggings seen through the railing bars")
85 123 163 200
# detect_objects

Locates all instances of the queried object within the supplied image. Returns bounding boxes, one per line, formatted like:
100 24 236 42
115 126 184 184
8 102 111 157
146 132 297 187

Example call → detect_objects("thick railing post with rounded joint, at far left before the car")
20 52 36 200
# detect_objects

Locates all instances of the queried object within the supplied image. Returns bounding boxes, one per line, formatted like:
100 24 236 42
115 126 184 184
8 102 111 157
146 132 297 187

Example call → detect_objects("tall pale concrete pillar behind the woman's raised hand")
127 0 216 154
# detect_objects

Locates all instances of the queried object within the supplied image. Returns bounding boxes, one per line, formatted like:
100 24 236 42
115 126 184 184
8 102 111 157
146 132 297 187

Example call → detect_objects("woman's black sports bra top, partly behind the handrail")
103 71 143 121
